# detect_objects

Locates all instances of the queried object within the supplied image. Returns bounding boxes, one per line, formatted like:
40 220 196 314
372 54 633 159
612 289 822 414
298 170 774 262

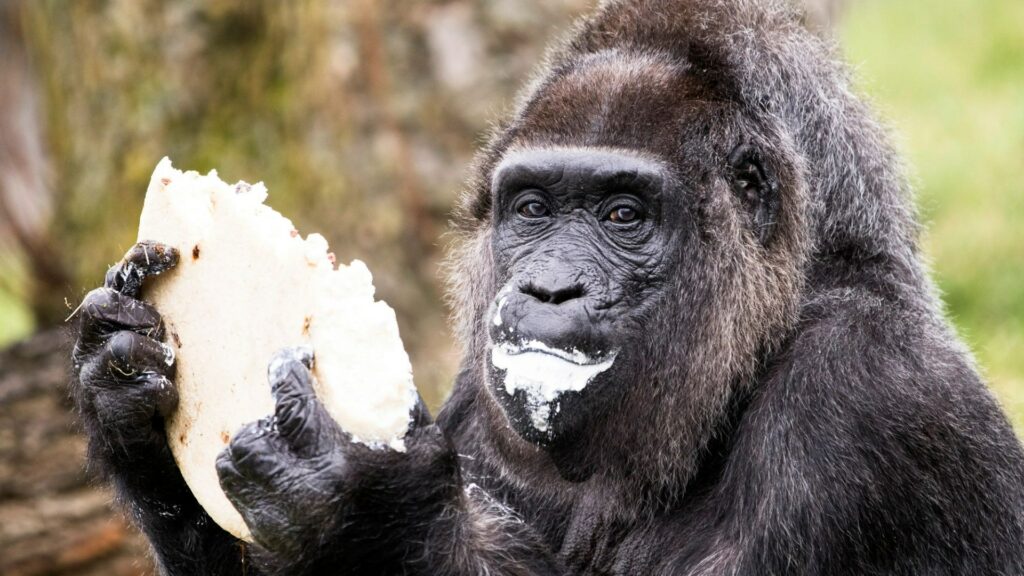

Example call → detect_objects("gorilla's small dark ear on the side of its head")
729 142 779 246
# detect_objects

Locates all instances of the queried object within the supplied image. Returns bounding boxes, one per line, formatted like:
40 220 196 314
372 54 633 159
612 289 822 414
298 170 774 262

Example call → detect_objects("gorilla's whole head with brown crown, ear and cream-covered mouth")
455 14 808 498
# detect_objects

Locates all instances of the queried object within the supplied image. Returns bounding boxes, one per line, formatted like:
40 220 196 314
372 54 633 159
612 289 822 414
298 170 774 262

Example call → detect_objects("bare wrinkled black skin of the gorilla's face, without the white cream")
488 149 681 446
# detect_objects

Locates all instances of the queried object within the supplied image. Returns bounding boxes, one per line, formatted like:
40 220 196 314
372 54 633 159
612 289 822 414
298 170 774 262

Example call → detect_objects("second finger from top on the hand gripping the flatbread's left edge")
79 288 164 346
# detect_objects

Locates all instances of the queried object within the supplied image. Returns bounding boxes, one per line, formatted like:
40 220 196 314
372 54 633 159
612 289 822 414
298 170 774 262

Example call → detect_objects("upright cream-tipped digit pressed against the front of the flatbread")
267 346 337 457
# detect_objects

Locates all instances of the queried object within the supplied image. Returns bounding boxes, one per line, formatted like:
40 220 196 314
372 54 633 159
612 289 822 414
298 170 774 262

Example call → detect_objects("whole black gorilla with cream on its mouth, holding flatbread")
74 0 1024 576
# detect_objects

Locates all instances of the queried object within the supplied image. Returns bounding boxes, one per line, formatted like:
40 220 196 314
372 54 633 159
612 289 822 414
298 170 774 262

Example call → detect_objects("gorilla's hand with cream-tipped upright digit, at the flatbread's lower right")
217 342 461 574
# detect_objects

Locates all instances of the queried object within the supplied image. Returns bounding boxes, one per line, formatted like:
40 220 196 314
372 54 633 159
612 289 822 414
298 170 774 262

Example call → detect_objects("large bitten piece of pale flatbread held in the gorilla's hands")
138 158 417 539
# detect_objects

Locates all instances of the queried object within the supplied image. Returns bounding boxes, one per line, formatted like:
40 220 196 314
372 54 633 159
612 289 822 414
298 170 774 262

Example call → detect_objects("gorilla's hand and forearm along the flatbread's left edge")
72 242 247 575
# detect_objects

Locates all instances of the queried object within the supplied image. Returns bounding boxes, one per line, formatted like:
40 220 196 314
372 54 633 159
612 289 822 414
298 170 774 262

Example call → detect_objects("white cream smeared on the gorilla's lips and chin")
490 340 617 431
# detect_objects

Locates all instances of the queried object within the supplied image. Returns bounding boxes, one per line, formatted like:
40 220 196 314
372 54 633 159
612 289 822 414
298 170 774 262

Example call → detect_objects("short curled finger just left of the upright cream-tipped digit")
218 416 292 477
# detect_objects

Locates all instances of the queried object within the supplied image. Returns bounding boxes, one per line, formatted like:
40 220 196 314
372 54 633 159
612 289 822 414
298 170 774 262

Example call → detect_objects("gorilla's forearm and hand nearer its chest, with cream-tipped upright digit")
217 348 563 575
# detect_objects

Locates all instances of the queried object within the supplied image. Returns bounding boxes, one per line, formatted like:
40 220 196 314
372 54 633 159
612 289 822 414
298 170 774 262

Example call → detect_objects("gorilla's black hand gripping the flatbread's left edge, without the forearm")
73 242 178 485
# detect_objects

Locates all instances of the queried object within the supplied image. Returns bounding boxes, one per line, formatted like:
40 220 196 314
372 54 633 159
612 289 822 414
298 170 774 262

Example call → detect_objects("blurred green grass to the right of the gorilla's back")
839 0 1024 433
